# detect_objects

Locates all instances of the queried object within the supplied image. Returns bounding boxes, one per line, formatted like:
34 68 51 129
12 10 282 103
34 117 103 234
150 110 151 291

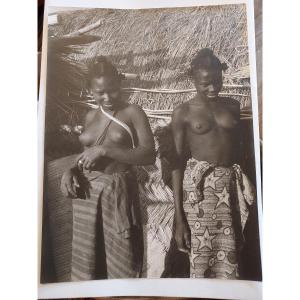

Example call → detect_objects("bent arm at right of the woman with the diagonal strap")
100 105 155 165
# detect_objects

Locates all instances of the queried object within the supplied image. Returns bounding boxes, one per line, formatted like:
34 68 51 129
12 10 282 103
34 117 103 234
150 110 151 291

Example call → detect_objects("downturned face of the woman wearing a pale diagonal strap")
91 76 120 110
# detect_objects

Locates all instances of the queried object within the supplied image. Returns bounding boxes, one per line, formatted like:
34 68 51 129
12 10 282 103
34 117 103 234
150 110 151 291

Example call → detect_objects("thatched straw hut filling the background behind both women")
45 4 258 277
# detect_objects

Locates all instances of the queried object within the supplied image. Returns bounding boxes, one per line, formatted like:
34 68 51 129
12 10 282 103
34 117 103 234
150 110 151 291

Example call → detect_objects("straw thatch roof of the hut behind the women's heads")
47 4 250 158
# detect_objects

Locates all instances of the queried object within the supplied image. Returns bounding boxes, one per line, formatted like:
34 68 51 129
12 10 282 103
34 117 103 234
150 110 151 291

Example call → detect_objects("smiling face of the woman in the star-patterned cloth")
193 69 223 99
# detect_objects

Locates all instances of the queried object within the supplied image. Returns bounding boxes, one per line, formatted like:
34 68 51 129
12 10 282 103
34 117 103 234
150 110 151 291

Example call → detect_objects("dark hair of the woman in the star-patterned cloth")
189 48 228 76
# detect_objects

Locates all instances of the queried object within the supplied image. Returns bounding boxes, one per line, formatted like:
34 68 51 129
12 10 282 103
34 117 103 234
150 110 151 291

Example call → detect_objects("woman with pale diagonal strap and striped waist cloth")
57 57 155 280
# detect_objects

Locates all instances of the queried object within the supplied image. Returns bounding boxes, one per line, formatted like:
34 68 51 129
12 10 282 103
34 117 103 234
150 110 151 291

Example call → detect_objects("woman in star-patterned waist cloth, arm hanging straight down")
172 48 254 279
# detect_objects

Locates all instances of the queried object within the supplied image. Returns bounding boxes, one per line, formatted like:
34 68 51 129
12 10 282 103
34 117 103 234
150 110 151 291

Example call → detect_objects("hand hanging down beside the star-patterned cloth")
175 218 191 253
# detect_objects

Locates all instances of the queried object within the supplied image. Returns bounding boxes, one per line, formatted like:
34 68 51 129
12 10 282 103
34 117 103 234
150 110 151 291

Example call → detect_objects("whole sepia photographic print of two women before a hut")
39 1 262 298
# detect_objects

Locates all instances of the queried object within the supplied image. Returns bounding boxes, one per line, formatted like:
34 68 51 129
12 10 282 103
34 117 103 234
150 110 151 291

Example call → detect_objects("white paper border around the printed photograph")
38 0 262 299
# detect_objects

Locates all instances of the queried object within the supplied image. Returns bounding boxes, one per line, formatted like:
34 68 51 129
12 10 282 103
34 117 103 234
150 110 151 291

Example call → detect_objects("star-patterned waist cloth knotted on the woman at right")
183 158 255 279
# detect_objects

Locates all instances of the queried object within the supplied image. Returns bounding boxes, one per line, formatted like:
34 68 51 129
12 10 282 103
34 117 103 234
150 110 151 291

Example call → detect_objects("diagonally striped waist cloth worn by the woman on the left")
71 171 142 281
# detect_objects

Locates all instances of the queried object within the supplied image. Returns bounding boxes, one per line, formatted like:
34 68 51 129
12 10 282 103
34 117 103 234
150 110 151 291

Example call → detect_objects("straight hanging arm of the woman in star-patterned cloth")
172 106 190 252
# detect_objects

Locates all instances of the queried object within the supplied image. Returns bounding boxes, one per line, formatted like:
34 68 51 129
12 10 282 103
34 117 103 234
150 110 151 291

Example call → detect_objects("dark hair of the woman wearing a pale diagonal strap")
88 56 122 81
